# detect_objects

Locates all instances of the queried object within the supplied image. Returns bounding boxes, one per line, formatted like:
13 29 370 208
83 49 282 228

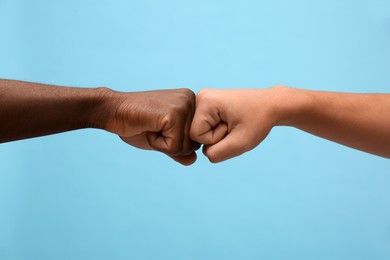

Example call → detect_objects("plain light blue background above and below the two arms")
0 0 390 260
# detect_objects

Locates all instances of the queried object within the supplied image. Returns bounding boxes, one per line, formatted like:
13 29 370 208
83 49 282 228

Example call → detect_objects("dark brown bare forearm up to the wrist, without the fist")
0 79 109 142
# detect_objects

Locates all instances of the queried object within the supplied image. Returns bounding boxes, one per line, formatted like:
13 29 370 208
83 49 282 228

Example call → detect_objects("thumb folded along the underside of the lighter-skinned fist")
203 128 254 163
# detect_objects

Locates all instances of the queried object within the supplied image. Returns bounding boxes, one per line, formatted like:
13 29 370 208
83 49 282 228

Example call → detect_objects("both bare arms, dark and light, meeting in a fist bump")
0 79 390 162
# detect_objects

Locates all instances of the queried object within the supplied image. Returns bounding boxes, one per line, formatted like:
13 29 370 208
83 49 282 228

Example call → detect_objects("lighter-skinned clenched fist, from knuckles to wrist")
190 89 278 162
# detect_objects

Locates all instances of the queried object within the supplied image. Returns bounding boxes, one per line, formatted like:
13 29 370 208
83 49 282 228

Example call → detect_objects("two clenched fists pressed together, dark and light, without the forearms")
105 89 286 165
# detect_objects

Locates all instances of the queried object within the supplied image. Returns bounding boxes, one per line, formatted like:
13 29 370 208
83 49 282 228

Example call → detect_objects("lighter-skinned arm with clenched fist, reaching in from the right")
190 86 390 163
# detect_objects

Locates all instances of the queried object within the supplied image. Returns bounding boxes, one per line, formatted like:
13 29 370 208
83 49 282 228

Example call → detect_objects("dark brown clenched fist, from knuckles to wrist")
106 89 199 165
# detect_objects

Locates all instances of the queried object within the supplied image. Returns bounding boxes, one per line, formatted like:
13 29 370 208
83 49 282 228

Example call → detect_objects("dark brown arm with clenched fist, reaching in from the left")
0 79 199 165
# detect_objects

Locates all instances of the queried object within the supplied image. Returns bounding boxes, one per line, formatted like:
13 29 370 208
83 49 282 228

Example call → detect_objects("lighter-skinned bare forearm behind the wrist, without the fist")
279 87 390 158
